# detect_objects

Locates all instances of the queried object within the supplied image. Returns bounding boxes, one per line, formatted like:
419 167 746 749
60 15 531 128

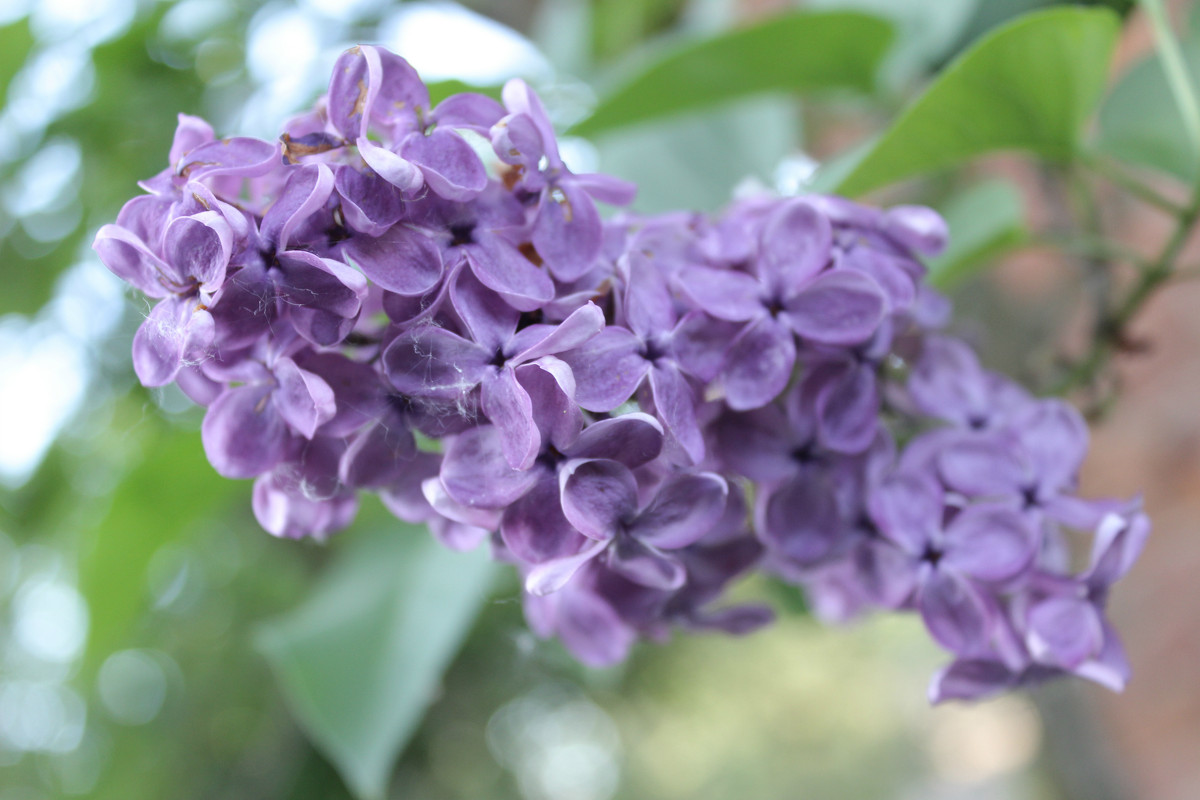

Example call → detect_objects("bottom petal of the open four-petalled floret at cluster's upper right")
721 317 796 411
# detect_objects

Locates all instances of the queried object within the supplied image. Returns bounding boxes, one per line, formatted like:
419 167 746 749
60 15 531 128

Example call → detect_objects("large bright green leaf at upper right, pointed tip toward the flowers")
838 8 1118 196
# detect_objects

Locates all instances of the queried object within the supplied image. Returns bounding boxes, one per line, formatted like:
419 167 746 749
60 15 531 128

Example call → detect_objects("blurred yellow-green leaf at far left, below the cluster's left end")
79 419 236 674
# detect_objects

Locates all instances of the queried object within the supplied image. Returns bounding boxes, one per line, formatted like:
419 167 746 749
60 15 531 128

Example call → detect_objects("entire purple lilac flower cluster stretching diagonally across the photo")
95 47 1148 699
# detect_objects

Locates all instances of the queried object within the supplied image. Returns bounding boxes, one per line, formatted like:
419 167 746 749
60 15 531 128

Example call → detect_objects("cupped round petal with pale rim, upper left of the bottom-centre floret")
558 459 637 541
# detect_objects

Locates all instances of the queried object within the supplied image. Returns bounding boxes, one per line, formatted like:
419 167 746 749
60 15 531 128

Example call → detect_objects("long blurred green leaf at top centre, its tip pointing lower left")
571 12 892 136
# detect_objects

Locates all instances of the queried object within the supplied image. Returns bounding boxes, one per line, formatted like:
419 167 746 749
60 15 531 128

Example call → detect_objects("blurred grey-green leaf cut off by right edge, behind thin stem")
1096 31 1200 184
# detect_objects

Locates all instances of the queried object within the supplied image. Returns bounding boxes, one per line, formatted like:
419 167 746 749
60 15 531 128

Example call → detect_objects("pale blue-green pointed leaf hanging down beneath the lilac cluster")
257 523 496 799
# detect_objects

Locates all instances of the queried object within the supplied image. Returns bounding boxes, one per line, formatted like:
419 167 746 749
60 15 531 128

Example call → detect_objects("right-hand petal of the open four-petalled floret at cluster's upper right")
785 270 887 344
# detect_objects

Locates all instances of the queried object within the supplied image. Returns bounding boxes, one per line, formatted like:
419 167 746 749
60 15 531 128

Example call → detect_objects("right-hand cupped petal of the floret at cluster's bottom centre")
629 473 730 551
